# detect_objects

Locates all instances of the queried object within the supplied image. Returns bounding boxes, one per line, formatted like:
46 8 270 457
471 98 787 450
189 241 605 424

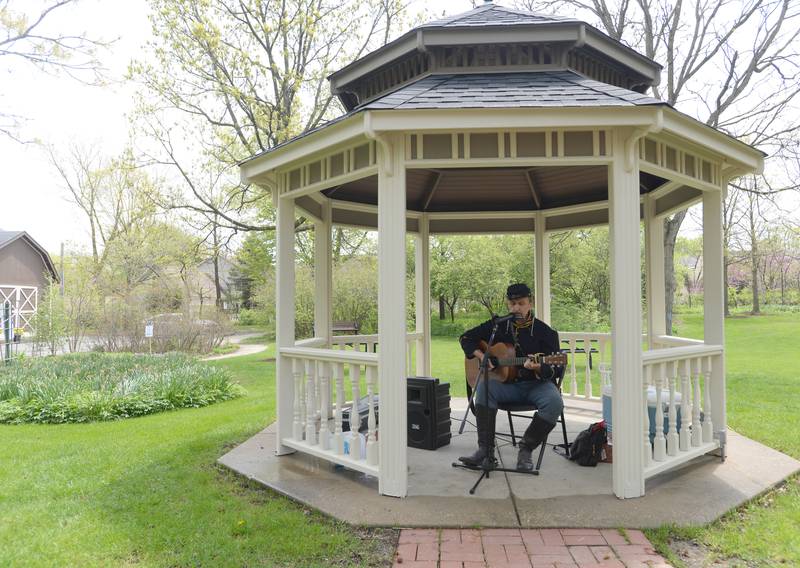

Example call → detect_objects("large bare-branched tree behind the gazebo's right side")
517 0 800 333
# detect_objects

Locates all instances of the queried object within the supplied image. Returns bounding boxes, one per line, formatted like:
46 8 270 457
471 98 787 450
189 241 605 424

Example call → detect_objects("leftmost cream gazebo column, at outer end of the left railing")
275 189 295 455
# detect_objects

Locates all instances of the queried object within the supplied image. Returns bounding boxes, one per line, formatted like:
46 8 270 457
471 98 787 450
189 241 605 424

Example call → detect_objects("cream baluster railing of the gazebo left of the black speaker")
280 346 380 476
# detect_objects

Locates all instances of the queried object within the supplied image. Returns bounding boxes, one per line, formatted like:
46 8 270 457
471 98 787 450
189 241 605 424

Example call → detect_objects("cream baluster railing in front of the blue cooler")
641 344 723 478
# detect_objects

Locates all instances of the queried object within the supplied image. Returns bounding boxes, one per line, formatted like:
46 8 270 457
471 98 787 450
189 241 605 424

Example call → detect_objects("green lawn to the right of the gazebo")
649 313 800 566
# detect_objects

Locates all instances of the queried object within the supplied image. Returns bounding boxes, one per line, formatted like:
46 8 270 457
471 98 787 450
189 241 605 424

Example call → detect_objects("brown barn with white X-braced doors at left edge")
0 230 59 329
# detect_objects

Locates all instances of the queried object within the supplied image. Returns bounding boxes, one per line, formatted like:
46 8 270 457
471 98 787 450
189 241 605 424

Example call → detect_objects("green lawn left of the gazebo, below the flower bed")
0 354 394 567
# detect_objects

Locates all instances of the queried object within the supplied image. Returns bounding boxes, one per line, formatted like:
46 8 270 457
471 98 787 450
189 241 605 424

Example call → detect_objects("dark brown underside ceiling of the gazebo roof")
322 166 667 213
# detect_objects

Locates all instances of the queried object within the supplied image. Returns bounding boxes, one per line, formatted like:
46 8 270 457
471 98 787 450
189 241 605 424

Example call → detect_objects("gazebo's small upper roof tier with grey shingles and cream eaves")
328 2 661 111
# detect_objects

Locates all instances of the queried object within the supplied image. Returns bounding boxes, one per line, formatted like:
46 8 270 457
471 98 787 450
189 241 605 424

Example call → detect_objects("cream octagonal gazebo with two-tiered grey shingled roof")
241 3 764 498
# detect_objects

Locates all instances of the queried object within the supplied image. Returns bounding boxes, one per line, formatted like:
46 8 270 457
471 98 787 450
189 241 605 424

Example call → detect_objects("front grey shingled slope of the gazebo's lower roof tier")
358 71 667 110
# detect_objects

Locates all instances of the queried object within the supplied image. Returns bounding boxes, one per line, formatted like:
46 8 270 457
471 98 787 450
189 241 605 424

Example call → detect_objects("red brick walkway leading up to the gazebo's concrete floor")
394 529 671 568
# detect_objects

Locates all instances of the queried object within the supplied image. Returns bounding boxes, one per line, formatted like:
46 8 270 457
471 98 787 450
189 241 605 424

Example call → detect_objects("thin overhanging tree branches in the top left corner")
0 0 110 142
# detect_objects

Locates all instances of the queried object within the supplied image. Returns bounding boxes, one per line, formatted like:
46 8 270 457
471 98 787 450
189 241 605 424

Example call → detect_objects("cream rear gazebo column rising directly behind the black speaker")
414 213 431 377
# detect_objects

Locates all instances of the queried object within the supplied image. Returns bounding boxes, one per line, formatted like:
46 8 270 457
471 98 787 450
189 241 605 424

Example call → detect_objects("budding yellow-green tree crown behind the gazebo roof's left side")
130 0 416 231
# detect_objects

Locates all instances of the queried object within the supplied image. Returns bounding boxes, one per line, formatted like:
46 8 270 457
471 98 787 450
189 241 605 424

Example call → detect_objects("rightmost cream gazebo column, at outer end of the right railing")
703 191 727 457
